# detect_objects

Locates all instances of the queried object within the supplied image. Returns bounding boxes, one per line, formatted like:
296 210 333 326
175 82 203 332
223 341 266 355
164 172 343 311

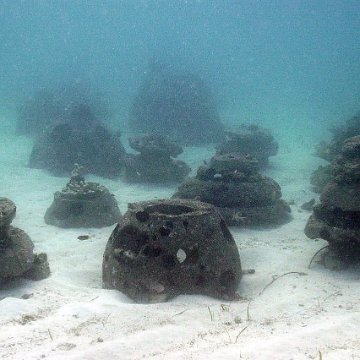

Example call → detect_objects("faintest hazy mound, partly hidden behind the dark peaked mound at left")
16 83 112 136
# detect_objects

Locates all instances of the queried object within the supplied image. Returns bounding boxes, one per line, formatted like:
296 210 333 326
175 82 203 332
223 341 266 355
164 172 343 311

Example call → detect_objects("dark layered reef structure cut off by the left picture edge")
0 197 50 288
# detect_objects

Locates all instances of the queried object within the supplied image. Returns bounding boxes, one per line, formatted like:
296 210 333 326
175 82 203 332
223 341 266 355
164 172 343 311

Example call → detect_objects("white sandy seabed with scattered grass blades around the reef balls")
0 119 360 360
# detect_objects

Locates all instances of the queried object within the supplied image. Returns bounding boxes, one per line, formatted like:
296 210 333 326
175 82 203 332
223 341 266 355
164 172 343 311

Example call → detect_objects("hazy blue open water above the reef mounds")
0 0 360 138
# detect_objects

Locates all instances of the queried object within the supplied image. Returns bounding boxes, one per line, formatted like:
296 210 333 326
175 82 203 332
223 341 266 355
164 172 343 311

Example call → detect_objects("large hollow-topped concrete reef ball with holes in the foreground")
103 200 241 303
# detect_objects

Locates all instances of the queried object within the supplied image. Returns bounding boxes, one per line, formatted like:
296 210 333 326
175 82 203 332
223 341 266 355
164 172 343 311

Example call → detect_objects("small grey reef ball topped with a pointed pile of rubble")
45 164 121 228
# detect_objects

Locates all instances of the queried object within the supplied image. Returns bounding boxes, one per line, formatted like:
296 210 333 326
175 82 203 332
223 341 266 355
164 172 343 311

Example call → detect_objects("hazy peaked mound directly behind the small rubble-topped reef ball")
29 103 125 178
